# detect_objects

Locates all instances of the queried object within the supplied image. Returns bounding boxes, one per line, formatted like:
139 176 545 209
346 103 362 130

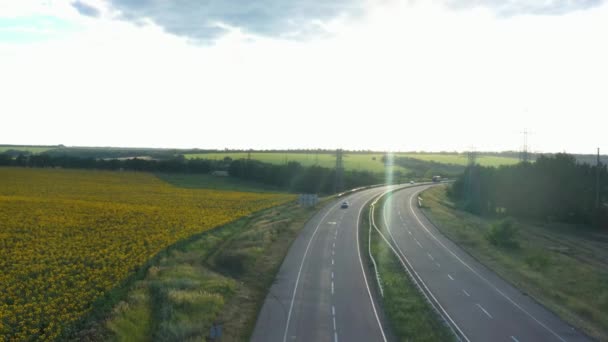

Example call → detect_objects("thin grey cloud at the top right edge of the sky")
445 0 604 17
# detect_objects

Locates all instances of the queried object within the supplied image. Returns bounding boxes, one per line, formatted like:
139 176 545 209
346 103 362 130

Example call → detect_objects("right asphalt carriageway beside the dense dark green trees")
382 186 589 342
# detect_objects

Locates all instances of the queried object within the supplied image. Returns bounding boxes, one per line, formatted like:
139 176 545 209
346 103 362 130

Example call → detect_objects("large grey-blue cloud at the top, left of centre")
104 0 364 42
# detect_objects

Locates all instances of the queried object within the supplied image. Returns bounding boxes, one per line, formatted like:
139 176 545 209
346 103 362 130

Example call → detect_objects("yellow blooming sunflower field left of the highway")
0 168 294 341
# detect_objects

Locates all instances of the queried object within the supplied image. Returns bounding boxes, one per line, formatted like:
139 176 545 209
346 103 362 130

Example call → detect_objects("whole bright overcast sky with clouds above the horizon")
0 0 608 153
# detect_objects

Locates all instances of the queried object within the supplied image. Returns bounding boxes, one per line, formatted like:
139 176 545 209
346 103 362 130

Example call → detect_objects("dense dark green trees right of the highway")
448 153 608 228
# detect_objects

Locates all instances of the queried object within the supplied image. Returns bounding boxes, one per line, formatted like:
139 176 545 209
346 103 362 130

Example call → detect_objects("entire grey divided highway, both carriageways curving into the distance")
251 186 589 342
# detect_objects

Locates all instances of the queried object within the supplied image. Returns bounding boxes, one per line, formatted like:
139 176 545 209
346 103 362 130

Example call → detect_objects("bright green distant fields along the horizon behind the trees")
185 152 518 172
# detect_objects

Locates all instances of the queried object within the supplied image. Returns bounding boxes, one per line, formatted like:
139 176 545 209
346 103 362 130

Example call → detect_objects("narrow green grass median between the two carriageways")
359 194 455 341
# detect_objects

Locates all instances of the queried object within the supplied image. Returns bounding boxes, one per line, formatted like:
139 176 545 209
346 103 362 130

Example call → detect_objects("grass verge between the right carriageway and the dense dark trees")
422 187 608 341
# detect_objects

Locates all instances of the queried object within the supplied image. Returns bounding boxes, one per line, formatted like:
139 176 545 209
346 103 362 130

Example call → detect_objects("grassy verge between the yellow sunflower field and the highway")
66 199 323 342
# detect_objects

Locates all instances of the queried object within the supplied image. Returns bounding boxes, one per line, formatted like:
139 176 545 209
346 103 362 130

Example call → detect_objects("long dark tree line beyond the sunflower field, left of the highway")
0 153 383 194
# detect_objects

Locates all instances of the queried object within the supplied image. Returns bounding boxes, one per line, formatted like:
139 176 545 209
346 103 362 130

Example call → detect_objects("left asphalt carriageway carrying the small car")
251 187 396 342
